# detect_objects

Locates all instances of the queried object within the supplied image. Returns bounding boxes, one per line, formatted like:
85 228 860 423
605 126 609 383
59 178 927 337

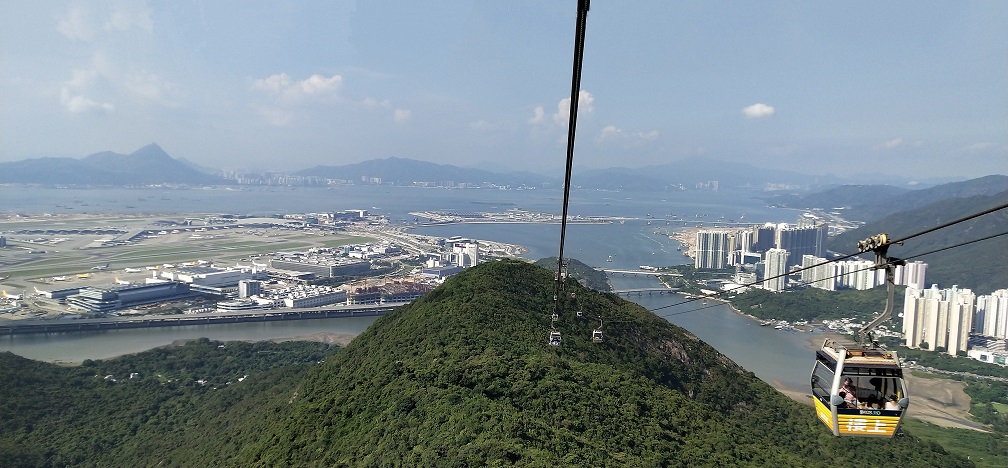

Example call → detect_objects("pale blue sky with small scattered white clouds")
0 0 1008 179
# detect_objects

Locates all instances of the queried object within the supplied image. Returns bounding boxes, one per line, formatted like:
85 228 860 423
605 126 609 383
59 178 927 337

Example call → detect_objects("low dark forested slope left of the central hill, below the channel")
0 339 337 467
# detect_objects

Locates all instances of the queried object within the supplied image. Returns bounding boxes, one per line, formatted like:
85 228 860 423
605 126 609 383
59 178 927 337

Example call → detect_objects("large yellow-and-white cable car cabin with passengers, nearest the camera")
811 340 910 437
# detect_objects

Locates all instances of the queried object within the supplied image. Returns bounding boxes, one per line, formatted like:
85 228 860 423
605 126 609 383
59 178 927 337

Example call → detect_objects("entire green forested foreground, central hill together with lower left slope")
0 261 971 468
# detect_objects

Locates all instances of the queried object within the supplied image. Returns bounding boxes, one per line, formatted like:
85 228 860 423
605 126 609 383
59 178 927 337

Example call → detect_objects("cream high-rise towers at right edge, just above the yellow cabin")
903 285 1008 365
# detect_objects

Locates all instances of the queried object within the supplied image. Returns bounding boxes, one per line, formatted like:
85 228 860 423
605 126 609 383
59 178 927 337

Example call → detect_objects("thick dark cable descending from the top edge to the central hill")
553 0 590 315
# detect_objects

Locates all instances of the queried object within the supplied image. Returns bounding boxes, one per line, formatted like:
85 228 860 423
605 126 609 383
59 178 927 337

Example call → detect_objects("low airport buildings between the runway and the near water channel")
49 237 480 314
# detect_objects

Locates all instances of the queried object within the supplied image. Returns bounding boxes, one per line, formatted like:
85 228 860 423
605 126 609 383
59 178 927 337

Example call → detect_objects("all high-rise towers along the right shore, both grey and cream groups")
692 216 1008 365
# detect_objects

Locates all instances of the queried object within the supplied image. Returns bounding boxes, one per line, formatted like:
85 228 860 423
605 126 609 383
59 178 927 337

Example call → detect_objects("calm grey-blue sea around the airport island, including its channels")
0 187 812 389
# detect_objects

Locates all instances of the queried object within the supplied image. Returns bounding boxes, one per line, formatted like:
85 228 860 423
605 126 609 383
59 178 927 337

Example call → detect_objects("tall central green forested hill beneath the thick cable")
244 261 969 467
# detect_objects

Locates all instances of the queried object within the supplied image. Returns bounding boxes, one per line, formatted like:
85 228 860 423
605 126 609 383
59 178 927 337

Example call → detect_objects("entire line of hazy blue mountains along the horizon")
0 143 1005 191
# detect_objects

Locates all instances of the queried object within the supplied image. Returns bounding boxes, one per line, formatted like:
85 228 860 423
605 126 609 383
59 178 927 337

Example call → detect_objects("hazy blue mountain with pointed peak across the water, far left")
0 143 227 186
